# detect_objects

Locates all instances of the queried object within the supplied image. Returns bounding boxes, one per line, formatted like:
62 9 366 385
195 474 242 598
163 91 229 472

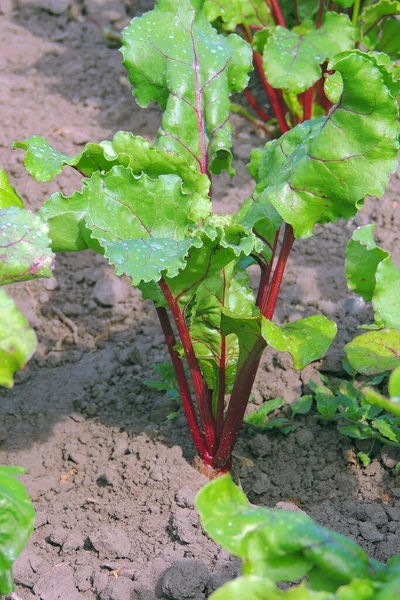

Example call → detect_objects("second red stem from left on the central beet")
158 279 215 455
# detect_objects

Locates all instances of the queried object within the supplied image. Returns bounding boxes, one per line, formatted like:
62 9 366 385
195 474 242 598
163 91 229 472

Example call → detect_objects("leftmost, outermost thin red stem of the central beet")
156 307 211 463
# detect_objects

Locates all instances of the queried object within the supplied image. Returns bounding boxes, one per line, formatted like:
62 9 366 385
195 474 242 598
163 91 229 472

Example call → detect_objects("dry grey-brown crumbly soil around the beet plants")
0 0 400 600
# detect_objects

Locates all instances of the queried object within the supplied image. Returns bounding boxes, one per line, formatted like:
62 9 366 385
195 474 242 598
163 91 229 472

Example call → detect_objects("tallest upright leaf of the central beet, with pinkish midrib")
121 0 252 173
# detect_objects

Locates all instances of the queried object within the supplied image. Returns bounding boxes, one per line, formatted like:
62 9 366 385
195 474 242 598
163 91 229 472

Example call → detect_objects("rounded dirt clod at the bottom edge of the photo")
156 560 210 600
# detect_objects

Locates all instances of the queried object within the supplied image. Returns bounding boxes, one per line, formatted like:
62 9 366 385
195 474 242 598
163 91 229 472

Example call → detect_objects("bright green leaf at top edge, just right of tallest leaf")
204 0 274 31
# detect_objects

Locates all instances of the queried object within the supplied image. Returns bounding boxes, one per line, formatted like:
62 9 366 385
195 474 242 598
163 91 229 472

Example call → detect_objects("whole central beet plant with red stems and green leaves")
15 0 398 472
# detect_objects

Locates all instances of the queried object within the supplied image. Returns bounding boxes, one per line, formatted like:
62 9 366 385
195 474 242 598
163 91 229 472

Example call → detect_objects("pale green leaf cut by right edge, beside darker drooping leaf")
372 256 400 332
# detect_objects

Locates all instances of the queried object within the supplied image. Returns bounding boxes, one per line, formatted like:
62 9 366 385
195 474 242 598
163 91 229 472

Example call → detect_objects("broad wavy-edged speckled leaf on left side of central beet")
41 166 206 285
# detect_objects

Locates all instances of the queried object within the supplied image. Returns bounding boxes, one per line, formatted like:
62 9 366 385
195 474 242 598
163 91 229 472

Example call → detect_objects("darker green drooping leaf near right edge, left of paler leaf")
346 224 389 301
